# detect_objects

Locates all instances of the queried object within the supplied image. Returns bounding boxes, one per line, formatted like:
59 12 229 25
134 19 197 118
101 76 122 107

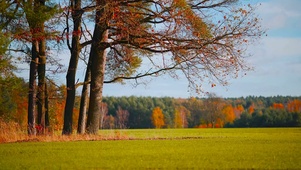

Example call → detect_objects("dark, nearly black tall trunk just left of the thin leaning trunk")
62 0 82 135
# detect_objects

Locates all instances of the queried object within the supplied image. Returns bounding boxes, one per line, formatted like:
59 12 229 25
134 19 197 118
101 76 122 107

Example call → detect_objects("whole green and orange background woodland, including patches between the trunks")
0 77 301 130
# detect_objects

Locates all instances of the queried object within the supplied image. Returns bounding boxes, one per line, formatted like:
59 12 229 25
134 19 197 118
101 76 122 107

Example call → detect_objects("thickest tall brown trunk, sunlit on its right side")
87 0 108 134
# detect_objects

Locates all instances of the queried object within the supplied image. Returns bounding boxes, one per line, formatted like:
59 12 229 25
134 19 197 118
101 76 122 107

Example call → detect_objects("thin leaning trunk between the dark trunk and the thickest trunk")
77 61 91 134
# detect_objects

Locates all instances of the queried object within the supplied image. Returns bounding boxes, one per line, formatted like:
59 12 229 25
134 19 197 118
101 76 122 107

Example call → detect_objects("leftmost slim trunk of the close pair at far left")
27 41 39 135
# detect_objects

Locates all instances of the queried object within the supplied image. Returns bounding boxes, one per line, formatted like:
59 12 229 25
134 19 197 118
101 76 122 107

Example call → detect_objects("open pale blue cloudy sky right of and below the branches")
100 0 301 98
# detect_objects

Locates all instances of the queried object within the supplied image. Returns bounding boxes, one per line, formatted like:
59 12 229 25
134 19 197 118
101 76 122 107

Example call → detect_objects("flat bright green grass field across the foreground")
0 128 301 169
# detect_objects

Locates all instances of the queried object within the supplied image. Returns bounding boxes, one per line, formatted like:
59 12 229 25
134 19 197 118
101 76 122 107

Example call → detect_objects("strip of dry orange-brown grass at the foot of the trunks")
0 118 130 143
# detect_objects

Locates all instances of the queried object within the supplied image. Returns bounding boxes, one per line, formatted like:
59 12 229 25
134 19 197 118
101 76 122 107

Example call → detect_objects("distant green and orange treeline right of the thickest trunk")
103 96 301 128
